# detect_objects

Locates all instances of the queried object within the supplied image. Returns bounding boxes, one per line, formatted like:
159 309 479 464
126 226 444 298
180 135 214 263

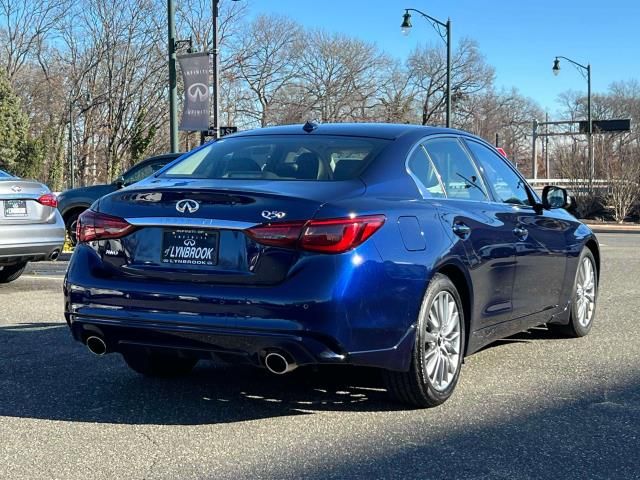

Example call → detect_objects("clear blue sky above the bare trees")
249 0 640 114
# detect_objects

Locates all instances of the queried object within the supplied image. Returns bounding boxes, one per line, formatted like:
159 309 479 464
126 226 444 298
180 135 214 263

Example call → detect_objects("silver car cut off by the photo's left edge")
0 170 64 283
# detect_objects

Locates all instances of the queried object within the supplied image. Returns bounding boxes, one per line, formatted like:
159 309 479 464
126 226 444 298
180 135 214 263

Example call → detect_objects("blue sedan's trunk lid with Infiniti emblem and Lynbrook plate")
95 180 364 285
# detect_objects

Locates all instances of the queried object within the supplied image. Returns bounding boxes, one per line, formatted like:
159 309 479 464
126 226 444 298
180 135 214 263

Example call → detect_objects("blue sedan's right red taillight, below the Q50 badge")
247 215 385 253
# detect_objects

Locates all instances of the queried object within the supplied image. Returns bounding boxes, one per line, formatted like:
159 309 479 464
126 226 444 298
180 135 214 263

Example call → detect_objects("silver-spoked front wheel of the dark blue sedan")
547 248 598 337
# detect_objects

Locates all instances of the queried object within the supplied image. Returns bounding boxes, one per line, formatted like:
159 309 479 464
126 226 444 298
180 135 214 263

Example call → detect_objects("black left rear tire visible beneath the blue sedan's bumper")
122 349 198 377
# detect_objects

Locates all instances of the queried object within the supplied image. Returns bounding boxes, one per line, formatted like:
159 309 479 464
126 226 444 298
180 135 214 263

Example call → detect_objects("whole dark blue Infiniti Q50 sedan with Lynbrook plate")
64 123 600 407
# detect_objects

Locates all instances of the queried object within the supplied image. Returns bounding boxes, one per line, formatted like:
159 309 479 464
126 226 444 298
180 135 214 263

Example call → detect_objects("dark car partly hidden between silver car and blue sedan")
58 153 181 245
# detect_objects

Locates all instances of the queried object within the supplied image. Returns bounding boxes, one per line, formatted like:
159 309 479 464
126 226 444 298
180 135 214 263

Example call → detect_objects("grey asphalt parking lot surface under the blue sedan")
0 234 640 479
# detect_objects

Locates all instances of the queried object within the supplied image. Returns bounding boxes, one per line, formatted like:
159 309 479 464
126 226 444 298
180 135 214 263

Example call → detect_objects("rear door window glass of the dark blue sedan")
424 138 488 201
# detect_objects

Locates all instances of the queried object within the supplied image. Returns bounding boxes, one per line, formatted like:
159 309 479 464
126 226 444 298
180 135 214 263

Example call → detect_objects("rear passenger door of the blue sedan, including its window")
424 137 515 329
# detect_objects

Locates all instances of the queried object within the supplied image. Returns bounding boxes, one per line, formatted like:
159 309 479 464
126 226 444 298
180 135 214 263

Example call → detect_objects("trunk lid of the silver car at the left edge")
0 178 53 225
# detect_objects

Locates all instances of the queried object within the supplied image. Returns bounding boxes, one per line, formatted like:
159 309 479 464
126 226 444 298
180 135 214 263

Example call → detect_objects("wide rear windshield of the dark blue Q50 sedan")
161 135 390 181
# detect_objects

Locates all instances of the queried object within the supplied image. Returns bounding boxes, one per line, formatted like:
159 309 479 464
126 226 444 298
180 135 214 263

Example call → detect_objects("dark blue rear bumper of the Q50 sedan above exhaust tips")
64 244 424 370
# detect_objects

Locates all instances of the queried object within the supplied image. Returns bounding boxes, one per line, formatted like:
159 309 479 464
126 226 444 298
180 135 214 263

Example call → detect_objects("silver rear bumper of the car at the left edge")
0 212 65 263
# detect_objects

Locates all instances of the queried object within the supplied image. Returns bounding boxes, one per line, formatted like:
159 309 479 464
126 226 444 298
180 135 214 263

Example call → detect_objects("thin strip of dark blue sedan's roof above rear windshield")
233 123 456 140
